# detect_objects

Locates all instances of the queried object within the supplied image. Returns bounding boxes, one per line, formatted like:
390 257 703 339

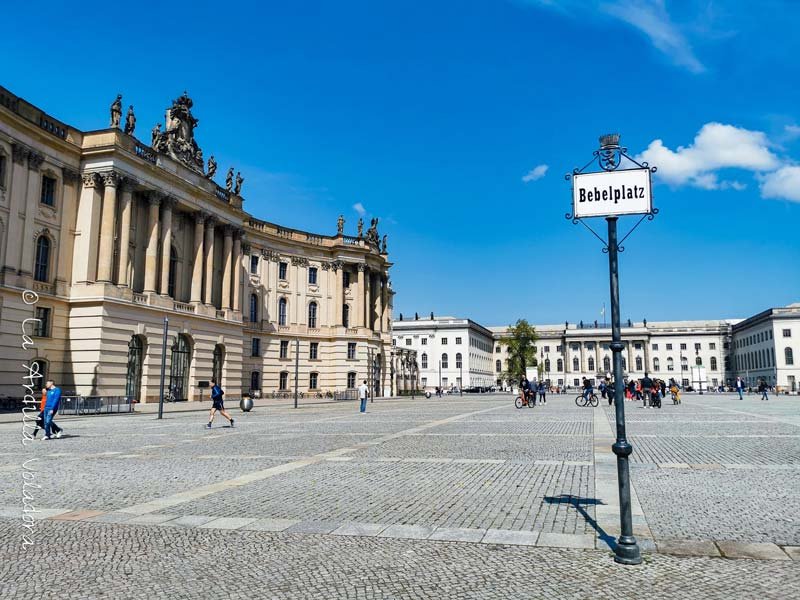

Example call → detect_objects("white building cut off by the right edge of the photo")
732 302 800 392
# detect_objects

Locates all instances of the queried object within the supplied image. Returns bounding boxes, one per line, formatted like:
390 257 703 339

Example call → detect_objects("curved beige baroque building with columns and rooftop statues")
0 87 394 402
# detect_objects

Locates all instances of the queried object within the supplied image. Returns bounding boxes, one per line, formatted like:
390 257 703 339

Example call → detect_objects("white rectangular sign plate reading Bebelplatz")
572 168 653 219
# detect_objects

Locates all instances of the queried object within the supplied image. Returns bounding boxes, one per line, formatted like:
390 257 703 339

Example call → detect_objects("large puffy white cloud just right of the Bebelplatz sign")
636 123 780 190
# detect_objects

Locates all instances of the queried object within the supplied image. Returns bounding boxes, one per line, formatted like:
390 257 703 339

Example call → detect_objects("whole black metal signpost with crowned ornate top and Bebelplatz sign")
566 134 658 565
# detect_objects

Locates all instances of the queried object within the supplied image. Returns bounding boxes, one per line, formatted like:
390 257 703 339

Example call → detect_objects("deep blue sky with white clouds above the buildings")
0 0 800 325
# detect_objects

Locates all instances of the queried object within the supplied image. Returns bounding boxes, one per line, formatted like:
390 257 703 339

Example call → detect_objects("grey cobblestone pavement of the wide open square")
0 395 800 599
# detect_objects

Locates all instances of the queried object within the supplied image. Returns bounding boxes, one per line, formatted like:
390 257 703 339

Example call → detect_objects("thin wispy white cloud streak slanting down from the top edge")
600 0 706 73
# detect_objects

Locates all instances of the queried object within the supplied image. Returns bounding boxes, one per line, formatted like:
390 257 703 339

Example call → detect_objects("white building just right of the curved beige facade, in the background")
392 315 495 390
